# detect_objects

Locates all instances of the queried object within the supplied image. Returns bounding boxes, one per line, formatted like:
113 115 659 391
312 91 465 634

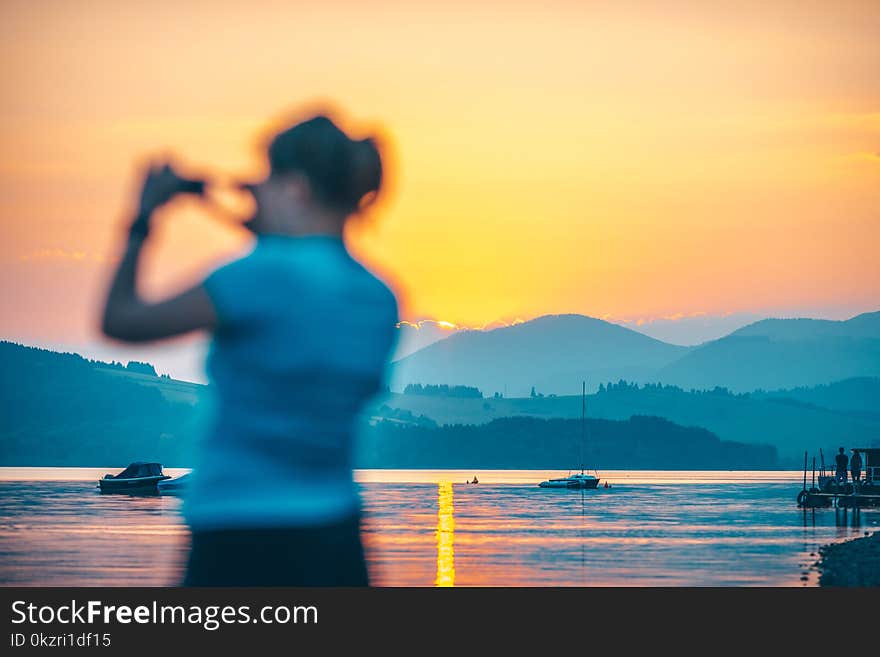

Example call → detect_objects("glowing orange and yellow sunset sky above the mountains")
0 0 880 340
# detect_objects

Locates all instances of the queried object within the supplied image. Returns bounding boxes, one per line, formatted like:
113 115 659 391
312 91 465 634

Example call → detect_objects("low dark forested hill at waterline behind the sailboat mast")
357 417 778 470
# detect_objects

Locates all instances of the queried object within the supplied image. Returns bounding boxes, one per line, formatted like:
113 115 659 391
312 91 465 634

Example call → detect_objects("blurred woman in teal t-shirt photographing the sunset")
103 116 397 586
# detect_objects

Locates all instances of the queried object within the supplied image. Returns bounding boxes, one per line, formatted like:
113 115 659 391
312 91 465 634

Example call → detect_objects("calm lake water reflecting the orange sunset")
0 468 880 586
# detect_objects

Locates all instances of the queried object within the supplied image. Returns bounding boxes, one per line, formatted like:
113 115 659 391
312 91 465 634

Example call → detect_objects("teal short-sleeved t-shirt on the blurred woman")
185 236 397 530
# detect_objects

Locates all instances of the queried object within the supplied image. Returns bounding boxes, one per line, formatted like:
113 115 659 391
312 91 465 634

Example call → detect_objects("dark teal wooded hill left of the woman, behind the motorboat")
0 342 206 465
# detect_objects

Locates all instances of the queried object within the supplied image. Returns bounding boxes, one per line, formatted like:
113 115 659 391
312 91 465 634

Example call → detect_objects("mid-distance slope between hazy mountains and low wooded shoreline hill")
373 379 880 465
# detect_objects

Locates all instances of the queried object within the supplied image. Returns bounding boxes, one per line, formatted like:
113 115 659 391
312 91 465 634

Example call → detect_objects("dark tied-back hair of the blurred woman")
269 116 382 214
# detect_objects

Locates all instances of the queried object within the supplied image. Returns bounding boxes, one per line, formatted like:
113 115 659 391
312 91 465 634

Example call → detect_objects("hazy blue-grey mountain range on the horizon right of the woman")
391 311 880 397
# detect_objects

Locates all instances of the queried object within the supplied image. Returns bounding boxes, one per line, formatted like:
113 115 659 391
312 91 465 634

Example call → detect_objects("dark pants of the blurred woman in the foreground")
183 516 369 586
